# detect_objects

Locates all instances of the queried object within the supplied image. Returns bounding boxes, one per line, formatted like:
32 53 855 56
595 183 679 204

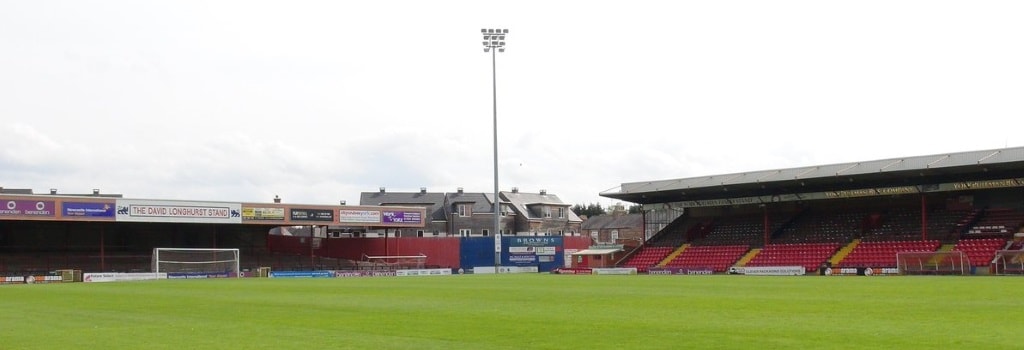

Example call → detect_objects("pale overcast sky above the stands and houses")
0 0 1024 205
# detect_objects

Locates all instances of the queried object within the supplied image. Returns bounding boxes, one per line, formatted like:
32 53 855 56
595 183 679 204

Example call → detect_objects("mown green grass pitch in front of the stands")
0 274 1024 350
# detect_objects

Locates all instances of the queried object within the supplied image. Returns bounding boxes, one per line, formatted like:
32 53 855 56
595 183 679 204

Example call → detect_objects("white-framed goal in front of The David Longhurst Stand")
153 248 240 278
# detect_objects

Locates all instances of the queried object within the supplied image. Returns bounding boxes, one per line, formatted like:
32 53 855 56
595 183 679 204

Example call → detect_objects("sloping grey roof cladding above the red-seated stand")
601 147 1024 199
